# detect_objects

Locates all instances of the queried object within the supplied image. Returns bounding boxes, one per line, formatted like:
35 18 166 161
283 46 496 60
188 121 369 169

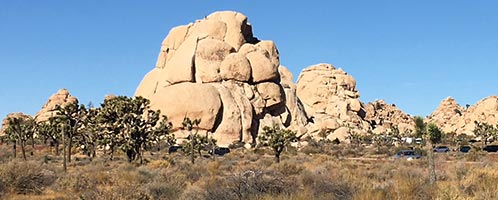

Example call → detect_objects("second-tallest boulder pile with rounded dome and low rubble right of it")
297 64 414 141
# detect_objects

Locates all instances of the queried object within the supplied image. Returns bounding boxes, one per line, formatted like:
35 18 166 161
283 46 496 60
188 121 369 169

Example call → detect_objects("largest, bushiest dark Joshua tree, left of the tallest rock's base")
98 96 171 164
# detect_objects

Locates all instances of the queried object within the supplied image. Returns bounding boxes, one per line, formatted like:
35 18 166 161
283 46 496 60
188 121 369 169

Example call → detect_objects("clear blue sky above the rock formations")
0 0 498 118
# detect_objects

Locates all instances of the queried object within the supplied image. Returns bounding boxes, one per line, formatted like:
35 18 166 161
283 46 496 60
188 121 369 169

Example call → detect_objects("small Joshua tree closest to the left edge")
6 116 36 160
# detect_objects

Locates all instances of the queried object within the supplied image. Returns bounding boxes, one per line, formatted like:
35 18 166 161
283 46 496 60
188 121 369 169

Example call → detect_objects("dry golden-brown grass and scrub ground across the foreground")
0 145 498 200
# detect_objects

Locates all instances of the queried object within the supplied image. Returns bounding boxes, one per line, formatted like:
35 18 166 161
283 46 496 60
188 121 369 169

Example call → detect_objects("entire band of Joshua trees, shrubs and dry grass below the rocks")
0 97 498 199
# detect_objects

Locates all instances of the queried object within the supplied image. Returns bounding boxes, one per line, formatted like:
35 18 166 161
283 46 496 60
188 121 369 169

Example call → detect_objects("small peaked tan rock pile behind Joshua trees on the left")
35 89 78 122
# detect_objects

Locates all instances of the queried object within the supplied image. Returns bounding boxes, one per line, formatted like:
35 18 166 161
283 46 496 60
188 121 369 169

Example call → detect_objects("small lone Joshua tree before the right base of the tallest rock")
258 124 297 163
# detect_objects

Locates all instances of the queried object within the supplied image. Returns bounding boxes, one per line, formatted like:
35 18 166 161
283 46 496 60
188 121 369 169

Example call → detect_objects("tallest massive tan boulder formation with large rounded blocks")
135 11 306 146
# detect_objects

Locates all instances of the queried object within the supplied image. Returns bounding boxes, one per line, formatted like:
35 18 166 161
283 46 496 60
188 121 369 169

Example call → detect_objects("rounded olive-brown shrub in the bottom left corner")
0 161 57 194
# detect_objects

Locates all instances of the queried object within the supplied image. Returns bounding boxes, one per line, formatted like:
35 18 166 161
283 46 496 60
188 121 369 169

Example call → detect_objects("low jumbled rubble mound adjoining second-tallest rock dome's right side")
365 100 415 134
